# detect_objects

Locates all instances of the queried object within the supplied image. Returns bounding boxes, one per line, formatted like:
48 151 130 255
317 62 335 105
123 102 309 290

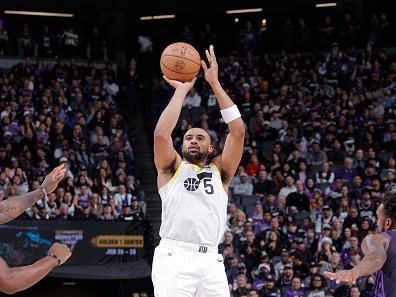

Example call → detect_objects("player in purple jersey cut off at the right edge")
325 185 396 297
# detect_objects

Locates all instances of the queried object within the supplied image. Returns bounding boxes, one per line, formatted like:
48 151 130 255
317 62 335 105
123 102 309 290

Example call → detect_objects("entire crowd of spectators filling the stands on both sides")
0 9 396 297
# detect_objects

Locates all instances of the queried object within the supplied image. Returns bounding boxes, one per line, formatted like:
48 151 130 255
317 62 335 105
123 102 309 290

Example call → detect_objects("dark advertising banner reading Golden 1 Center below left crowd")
0 220 152 278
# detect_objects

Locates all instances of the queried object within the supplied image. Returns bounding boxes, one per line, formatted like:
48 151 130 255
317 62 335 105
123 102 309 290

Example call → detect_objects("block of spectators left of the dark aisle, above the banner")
0 58 146 221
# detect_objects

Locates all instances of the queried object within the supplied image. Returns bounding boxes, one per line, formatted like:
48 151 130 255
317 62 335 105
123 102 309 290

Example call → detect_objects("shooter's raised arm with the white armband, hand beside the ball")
201 45 245 184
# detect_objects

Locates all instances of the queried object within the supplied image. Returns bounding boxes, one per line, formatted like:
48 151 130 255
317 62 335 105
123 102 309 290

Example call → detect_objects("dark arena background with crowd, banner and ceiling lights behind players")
0 0 396 297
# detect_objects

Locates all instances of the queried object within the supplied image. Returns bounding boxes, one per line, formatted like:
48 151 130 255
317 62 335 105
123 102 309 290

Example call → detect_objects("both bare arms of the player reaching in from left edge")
0 165 71 294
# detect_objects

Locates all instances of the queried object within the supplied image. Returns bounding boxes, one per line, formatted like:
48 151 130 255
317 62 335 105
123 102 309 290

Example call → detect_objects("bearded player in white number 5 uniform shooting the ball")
152 46 245 297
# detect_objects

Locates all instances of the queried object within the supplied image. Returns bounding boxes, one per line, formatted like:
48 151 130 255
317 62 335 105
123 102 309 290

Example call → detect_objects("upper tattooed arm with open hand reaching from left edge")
0 165 67 224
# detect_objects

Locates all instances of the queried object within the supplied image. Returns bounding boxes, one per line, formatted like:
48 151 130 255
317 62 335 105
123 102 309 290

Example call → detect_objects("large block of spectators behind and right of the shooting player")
158 12 396 297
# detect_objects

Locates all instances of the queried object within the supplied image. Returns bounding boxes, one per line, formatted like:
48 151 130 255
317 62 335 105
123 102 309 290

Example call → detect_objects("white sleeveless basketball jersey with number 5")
159 161 228 246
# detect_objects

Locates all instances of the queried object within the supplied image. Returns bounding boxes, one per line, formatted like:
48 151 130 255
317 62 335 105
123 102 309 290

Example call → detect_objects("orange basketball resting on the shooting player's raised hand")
160 42 201 82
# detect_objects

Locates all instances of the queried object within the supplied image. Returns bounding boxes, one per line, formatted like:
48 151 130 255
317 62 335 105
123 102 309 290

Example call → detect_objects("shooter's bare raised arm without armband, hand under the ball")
154 76 196 172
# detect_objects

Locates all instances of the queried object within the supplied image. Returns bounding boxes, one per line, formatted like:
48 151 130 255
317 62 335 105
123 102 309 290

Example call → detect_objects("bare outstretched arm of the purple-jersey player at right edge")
325 234 389 283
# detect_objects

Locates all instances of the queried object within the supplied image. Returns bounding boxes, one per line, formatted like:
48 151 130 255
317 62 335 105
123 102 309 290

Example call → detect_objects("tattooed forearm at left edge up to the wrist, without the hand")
0 190 44 224
